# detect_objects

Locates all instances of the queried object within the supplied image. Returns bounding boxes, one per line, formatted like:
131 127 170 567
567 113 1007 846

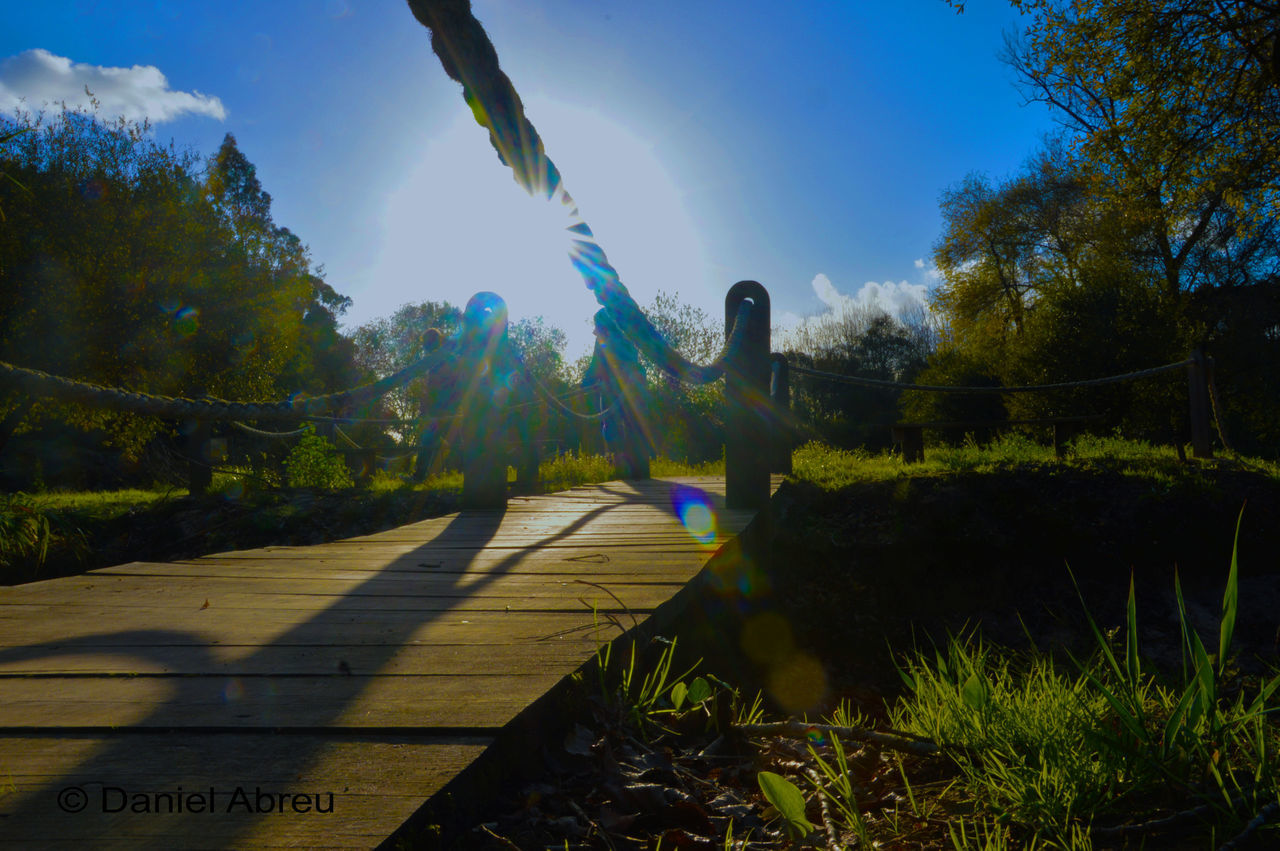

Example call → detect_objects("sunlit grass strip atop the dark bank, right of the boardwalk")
792 431 1280 490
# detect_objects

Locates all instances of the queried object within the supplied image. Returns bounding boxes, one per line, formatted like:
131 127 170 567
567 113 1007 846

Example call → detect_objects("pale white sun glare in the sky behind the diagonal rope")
369 97 717 360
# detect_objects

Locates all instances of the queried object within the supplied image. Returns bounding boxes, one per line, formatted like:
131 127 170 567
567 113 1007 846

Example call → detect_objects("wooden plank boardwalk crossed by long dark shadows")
0 477 773 848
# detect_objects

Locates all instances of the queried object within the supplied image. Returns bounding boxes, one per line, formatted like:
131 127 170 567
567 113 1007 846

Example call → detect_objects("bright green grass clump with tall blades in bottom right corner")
890 516 1280 847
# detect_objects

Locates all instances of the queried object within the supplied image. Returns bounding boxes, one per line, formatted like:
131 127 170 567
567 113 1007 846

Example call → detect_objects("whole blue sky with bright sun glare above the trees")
0 0 1052 357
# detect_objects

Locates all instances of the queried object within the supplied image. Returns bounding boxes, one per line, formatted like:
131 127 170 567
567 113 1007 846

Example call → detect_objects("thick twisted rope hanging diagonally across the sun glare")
408 0 723 381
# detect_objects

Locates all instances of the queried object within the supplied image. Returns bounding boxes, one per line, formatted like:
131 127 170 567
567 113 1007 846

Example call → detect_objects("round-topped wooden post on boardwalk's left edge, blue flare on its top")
460 293 509 509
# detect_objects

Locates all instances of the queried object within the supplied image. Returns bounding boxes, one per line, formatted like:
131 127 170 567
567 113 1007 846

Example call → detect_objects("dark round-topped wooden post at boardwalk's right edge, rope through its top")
724 280 772 511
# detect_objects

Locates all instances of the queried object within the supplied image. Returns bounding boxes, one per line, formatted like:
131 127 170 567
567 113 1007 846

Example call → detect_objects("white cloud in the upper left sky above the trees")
0 47 227 124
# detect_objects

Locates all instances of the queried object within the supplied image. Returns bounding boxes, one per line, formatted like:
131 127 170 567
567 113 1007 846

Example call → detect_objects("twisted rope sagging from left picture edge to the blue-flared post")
0 339 458 422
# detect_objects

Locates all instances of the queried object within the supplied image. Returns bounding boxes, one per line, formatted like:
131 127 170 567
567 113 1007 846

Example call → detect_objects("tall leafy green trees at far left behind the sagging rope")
0 107 355 473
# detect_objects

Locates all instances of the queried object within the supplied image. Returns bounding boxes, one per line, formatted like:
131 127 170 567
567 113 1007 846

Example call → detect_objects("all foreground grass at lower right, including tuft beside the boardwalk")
583 516 1280 851
